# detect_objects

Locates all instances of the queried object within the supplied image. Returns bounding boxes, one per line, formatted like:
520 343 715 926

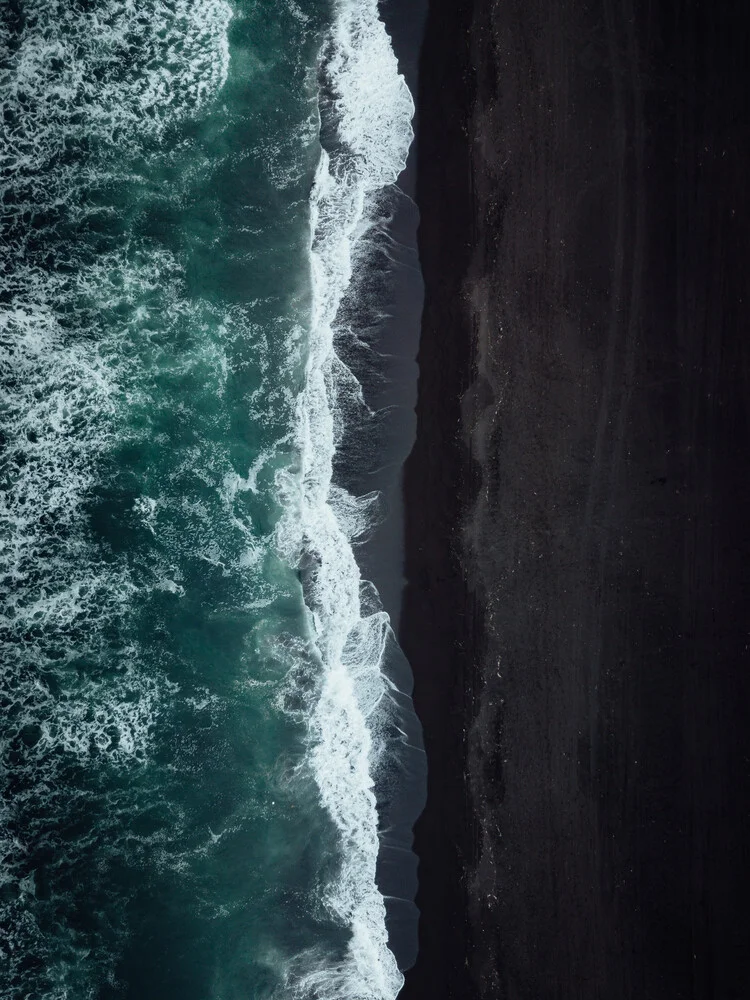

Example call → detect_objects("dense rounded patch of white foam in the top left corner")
0 0 232 168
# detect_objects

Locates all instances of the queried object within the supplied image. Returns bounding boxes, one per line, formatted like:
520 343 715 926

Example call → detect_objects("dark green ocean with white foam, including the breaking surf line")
0 0 424 1000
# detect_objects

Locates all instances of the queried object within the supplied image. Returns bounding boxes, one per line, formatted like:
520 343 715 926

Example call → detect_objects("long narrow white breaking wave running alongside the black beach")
300 0 423 998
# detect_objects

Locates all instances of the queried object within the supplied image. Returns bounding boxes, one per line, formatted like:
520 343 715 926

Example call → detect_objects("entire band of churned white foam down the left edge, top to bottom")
0 0 231 1000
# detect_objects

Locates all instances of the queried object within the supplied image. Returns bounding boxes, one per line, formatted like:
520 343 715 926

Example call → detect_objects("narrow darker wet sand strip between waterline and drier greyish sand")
399 0 476 1000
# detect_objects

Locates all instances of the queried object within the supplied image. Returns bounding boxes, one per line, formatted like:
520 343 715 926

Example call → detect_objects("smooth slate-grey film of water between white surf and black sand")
336 0 426 970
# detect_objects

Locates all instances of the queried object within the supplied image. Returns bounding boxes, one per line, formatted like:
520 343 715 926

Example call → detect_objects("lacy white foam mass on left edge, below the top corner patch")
0 274 170 997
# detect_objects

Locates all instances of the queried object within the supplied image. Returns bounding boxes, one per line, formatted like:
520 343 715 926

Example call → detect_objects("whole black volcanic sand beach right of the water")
401 0 750 1000
